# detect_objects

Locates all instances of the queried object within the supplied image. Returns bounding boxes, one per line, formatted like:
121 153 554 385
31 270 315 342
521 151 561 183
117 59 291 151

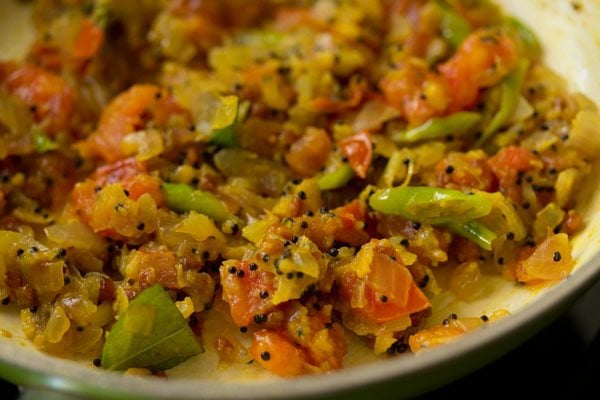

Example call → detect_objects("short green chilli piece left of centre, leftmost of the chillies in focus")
162 182 235 222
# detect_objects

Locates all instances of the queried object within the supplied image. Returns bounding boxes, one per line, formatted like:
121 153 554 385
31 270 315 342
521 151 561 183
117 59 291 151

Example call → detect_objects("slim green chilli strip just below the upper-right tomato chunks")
392 111 482 144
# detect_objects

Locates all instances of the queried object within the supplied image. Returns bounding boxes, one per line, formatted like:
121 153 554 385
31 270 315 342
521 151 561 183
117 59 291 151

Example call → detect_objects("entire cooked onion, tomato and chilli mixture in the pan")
0 0 600 377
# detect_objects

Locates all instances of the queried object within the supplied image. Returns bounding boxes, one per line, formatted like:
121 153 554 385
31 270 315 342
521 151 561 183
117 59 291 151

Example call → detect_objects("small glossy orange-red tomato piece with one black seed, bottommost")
250 329 305 378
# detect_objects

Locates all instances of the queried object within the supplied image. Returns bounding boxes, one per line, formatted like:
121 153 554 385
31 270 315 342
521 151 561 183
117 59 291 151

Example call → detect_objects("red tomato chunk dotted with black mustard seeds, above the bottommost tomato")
220 261 275 326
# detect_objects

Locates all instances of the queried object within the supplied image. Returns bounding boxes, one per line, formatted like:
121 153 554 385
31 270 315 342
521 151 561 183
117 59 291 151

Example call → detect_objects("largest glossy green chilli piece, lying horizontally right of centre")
369 186 492 225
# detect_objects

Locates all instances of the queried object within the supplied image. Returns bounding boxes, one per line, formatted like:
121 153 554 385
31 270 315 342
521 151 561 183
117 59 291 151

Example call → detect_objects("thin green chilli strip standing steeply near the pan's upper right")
475 59 529 147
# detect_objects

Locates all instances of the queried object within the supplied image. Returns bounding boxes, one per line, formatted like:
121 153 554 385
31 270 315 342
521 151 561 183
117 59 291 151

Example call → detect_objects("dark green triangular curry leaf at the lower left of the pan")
102 285 204 371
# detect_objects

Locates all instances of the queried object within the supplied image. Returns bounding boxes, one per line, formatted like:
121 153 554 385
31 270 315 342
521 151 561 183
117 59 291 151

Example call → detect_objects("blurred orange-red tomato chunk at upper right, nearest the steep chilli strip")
439 29 517 112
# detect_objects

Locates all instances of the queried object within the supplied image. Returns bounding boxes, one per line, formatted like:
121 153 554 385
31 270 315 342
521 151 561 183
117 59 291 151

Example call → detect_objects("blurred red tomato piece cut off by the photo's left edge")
0 63 73 136
